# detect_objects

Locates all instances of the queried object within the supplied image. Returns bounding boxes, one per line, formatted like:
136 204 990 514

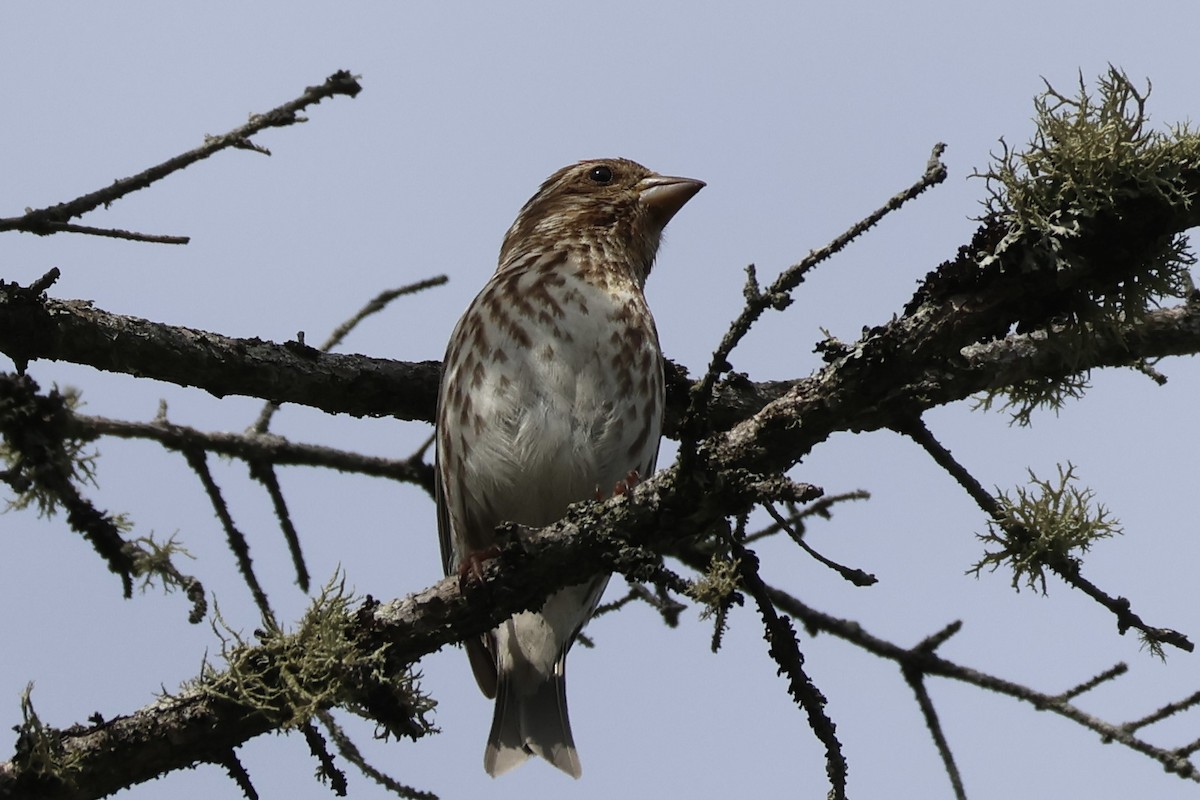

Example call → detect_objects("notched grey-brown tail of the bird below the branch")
484 658 582 777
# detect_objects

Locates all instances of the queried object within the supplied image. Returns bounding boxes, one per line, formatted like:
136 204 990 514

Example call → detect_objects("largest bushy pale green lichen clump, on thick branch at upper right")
977 67 1200 425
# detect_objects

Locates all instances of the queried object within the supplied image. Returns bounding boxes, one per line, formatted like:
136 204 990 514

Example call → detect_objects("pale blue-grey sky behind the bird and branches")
0 0 1200 800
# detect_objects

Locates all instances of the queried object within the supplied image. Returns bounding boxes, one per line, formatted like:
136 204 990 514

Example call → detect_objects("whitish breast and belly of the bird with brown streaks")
450 262 664 525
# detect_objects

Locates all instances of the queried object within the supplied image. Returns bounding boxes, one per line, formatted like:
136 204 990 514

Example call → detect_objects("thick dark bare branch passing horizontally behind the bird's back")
9 277 1200 441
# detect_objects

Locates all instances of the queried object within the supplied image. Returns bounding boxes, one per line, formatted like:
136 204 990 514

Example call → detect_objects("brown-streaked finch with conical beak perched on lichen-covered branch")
434 158 704 778
